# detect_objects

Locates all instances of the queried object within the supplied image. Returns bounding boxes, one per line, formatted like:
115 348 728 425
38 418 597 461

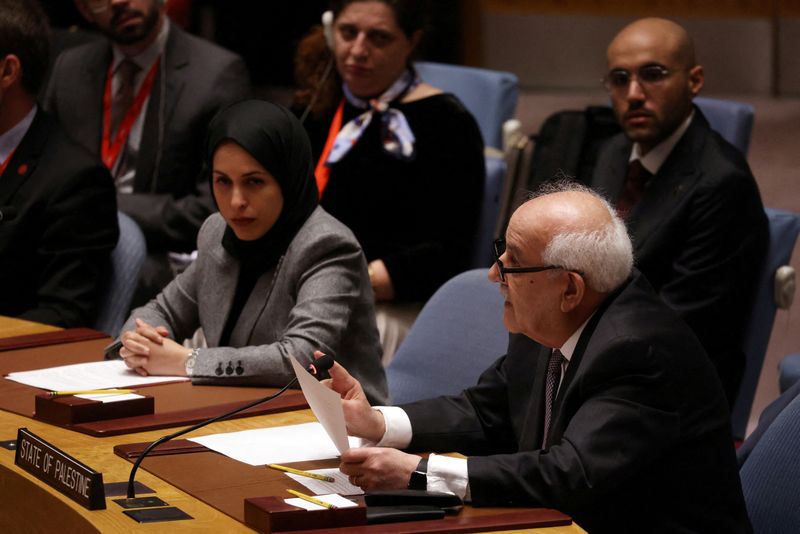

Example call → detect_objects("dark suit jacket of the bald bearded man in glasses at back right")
591 108 769 405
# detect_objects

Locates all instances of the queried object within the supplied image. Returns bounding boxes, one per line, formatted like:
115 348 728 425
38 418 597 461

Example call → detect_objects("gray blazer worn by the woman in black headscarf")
123 207 388 404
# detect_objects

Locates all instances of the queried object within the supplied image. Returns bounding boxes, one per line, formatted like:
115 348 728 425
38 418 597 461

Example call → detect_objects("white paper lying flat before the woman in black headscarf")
6 360 189 391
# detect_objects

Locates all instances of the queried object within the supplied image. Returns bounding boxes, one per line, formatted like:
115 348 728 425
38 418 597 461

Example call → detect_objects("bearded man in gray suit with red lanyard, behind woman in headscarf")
45 0 250 304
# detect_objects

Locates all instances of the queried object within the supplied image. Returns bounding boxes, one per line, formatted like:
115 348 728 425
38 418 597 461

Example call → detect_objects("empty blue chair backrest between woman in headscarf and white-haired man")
386 269 508 404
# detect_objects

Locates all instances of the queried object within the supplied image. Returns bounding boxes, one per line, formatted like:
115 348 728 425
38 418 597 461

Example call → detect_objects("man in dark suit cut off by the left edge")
0 0 118 327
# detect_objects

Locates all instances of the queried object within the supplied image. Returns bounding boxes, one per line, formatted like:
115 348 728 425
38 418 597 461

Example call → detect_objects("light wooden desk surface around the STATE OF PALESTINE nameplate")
0 410 585 534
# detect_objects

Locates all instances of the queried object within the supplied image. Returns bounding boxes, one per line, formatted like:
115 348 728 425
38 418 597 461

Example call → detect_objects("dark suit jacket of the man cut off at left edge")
0 110 119 327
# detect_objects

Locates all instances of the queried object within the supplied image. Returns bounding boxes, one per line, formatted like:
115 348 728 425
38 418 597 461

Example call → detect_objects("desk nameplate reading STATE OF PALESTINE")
14 428 106 510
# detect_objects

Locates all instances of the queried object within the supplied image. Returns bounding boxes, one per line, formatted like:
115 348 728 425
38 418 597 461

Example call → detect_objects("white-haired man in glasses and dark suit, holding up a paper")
318 184 750 533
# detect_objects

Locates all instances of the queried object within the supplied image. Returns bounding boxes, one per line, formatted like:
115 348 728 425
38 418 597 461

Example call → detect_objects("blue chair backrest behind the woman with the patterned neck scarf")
415 61 518 149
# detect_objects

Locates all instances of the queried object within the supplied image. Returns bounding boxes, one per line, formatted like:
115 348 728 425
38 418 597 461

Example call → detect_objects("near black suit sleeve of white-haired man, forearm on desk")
468 342 680 510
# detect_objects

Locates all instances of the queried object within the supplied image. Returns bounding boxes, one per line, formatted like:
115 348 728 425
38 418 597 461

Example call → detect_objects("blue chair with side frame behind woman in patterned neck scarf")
415 62 518 268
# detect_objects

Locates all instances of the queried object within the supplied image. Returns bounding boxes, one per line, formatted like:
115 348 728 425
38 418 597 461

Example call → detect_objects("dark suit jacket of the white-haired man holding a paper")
403 273 749 533
